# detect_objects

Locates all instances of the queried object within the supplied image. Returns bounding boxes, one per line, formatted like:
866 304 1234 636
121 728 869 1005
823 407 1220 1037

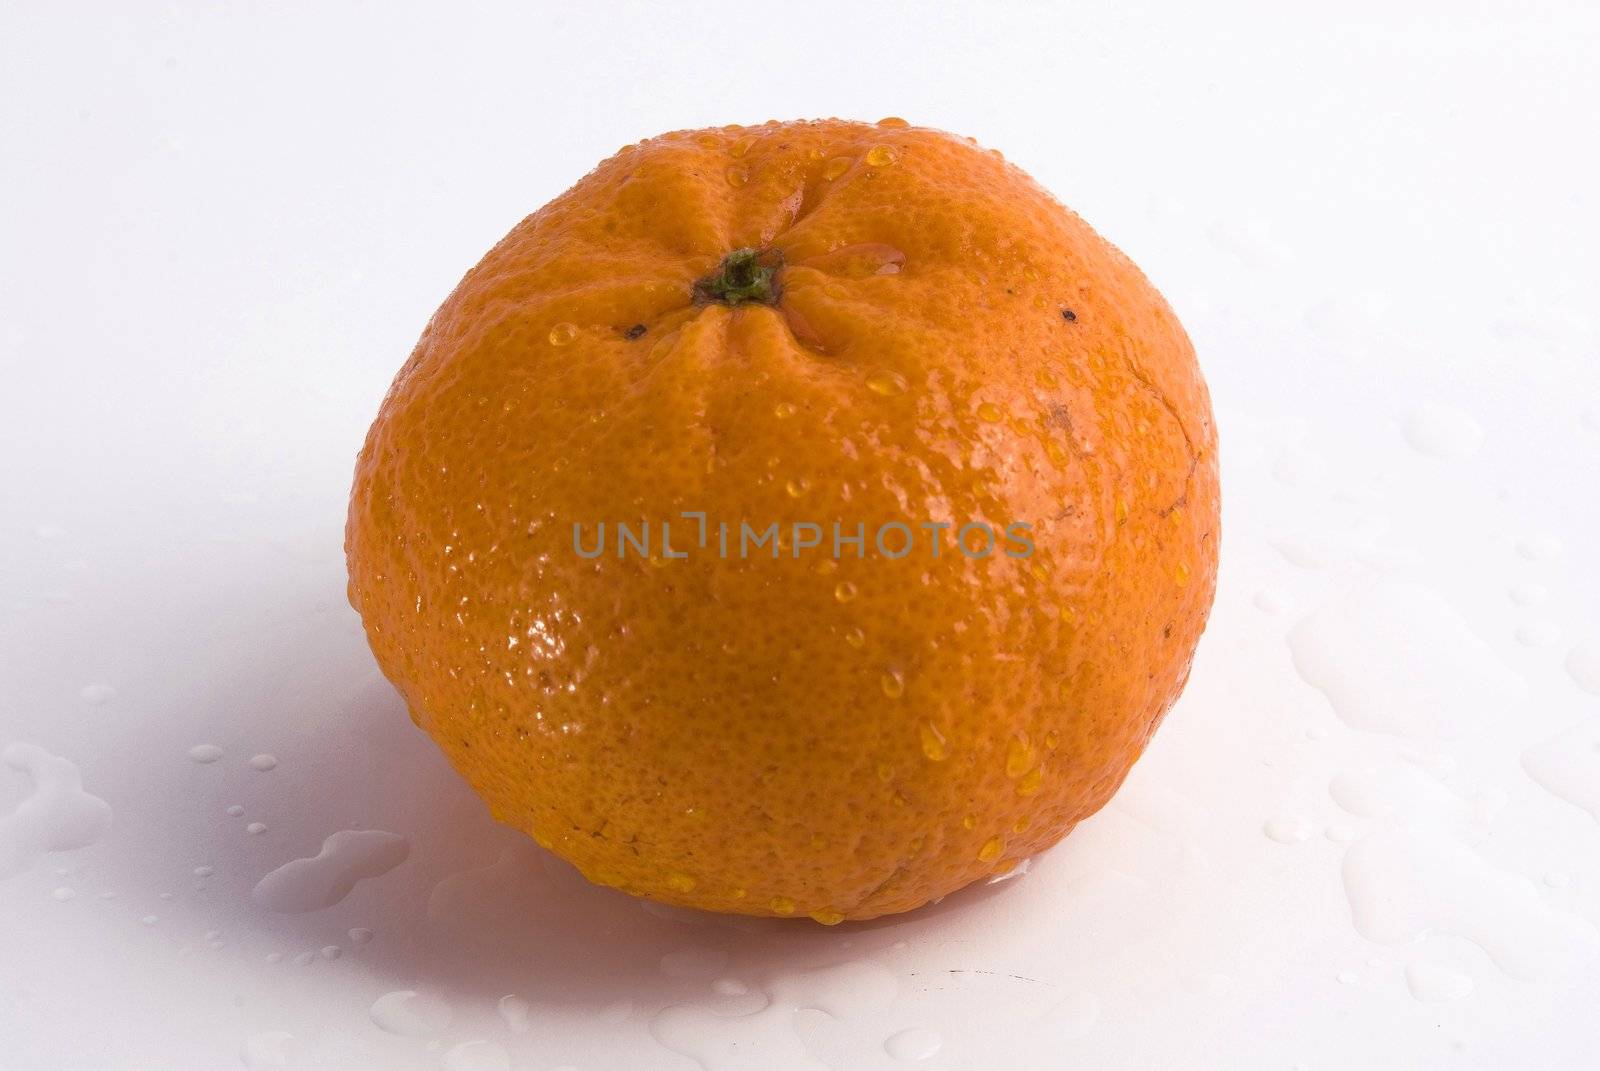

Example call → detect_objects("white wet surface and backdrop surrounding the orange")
0 3 1600 1071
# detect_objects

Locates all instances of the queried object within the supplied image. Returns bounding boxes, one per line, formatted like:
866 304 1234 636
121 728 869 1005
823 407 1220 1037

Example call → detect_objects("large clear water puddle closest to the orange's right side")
1288 581 1526 740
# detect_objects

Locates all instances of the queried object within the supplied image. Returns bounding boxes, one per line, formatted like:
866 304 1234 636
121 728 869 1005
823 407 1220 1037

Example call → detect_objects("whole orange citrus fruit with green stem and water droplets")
346 120 1218 924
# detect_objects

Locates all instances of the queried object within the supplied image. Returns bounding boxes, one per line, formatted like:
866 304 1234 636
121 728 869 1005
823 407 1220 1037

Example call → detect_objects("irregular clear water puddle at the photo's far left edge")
0 744 112 879
